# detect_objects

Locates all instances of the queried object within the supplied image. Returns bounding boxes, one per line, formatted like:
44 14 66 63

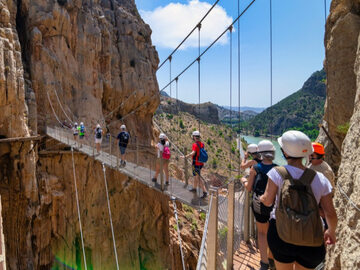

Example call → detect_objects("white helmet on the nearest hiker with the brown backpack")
278 130 314 158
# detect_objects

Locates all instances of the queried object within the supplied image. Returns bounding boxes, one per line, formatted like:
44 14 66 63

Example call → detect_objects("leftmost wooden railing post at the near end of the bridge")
207 188 218 270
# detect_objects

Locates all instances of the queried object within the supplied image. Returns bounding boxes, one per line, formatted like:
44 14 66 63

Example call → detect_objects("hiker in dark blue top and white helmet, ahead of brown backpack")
241 140 277 270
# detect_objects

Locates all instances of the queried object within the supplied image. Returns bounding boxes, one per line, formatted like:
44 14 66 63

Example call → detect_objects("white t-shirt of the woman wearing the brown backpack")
267 165 332 219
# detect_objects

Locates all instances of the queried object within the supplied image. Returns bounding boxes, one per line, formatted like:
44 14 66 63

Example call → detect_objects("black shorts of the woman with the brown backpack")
267 219 325 268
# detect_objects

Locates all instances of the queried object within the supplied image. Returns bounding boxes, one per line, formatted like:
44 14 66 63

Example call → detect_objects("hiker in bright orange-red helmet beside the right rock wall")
308 143 335 188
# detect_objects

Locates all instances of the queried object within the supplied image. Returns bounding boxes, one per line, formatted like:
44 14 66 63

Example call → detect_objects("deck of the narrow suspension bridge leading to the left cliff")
45 127 210 211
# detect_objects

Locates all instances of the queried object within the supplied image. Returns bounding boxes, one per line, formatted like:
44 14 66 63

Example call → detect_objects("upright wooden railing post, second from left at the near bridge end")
226 181 235 270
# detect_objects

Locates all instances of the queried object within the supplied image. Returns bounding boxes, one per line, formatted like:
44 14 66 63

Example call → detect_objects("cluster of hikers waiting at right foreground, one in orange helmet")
241 130 337 270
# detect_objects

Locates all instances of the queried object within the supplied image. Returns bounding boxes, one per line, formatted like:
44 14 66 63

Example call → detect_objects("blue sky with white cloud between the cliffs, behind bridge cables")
135 0 330 107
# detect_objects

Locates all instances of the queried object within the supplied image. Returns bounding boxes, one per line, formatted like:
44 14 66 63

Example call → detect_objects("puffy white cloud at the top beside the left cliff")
140 0 233 49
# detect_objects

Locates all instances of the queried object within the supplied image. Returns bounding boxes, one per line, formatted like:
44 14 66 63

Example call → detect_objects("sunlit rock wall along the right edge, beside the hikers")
321 0 360 269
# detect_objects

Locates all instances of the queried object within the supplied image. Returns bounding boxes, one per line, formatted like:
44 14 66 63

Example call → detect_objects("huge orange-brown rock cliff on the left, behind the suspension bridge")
0 0 171 269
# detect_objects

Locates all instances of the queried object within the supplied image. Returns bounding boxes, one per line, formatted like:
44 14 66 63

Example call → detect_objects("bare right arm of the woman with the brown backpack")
320 193 337 245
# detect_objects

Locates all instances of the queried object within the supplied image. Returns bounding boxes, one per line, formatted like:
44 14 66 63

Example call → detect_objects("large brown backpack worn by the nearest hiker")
275 167 324 247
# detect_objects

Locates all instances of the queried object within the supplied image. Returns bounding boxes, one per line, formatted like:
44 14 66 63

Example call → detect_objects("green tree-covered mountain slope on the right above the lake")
245 70 326 139
